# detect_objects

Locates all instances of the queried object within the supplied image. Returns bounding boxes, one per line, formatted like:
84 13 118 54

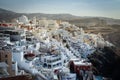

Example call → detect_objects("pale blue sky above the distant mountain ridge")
0 0 120 19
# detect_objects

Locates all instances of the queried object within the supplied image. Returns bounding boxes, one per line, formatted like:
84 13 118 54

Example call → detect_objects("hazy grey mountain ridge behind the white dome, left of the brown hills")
0 8 79 22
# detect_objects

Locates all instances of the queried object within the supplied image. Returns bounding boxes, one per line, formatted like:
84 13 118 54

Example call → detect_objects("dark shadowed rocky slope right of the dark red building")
88 47 120 80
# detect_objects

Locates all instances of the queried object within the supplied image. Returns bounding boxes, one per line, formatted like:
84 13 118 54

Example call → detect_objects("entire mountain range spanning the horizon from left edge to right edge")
0 8 120 25
